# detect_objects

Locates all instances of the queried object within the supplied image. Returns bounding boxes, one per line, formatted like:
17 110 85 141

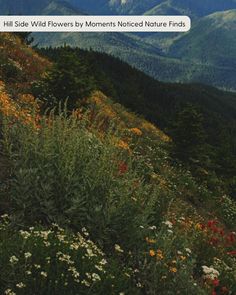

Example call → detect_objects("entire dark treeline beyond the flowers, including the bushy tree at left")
36 46 236 196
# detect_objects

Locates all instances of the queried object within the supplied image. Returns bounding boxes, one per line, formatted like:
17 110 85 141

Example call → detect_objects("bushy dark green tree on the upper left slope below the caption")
33 47 94 110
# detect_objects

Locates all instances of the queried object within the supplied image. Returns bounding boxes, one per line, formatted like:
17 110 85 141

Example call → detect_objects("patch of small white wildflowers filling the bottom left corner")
0 215 132 295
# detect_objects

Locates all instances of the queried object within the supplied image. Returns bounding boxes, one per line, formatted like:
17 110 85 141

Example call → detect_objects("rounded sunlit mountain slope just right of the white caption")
169 10 236 69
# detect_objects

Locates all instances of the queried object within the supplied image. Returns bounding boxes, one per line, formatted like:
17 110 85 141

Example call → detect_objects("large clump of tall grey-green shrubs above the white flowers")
1 113 168 248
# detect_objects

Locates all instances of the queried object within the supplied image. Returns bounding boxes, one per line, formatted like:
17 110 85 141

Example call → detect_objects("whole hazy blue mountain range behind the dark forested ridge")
0 0 236 89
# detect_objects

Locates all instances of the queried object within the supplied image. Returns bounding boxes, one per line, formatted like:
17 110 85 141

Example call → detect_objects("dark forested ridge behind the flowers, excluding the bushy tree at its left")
36 47 236 198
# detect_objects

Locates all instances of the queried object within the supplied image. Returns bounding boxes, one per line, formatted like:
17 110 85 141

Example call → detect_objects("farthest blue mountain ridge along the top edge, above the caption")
70 0 236 18
